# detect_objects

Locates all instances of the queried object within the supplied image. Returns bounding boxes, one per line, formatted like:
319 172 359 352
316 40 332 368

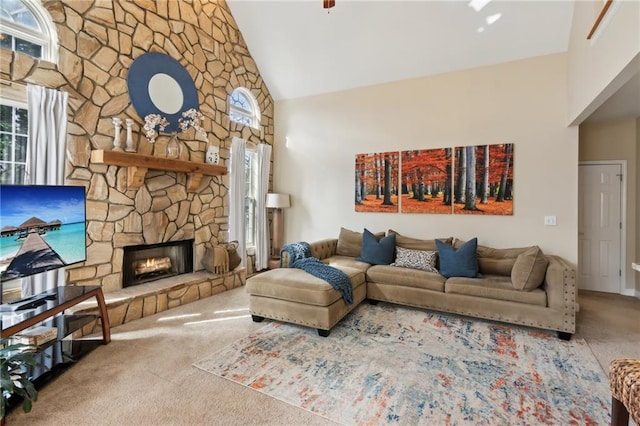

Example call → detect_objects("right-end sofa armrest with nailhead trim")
543 256 576 329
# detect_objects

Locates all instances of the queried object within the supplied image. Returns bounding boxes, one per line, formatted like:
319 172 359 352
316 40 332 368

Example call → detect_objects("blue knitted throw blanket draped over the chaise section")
280 241 353 305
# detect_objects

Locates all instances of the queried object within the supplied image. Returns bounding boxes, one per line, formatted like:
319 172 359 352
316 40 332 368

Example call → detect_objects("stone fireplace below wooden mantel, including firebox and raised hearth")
67 168 246 335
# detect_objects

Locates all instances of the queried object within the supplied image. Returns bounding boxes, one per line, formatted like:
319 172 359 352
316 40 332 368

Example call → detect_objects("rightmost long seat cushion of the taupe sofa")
444 275 547 306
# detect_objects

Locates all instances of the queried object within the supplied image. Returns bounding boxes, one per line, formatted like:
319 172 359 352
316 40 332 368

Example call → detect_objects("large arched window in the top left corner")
0 0 58 62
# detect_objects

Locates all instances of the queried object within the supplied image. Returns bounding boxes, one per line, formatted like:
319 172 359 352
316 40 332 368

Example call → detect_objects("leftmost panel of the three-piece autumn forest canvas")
355 151 400 213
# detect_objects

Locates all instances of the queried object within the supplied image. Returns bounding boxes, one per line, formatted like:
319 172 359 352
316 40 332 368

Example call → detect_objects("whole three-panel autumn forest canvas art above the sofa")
355 143 514 215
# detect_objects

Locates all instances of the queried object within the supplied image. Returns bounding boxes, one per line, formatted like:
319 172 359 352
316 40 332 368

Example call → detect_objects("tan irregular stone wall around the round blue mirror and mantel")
0 0 273 293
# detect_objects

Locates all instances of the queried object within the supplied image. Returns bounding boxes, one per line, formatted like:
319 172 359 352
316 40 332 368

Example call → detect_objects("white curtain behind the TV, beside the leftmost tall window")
22 84 68 297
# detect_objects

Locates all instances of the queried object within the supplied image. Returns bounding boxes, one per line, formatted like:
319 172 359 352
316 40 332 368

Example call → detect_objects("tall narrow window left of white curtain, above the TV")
0 101 29 184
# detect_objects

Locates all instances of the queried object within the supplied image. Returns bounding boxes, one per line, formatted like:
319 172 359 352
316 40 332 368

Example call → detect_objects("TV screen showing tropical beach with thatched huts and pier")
0 185 86 281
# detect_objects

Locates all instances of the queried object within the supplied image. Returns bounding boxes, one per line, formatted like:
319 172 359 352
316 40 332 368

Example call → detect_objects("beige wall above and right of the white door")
579 119 640 293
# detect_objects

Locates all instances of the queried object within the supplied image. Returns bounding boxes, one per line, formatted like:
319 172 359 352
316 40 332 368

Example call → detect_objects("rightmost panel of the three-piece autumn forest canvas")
453 143 513 215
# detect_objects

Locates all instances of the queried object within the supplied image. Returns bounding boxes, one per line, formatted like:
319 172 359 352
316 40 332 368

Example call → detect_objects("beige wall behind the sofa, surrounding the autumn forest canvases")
274 54 578 262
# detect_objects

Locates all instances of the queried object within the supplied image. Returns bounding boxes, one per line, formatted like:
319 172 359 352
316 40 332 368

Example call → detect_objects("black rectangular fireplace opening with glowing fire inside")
122 240 194 287
